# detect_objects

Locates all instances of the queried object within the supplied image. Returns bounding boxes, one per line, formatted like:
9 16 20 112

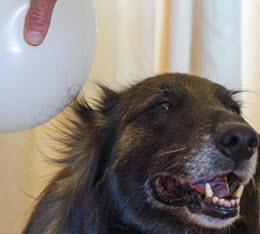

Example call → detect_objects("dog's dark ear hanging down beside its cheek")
88 85 120 186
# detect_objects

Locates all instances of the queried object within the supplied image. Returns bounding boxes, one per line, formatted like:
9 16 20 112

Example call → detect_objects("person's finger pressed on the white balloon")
23 0 57 46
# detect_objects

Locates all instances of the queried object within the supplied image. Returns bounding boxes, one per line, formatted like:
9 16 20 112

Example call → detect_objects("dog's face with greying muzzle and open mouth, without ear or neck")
107 74 259 228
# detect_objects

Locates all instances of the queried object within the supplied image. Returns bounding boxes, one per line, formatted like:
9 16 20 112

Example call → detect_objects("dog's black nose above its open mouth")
216 124 259 161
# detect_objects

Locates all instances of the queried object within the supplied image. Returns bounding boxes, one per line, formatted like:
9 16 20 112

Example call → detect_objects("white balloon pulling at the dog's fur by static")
0 0 97 133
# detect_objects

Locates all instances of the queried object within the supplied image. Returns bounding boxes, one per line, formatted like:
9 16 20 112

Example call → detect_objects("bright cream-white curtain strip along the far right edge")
242 0 260 133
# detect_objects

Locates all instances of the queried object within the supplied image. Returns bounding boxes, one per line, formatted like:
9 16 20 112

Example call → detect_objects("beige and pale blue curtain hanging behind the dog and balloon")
0 0 260 234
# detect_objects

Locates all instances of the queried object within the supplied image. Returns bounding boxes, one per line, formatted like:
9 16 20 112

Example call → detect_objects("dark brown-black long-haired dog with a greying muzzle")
23 73 260 234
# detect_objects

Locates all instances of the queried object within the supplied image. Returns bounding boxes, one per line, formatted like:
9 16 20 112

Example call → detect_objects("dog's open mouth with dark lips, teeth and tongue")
149 173 244 219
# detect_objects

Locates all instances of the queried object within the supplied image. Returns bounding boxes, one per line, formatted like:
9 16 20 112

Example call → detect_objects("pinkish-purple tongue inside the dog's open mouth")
190 177 228 198
